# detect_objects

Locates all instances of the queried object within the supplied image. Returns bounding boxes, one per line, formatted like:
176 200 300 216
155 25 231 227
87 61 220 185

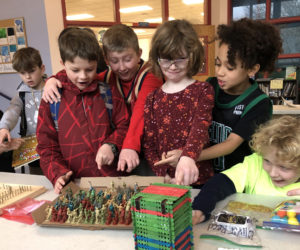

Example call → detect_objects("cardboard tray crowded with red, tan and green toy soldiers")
32 176 163 230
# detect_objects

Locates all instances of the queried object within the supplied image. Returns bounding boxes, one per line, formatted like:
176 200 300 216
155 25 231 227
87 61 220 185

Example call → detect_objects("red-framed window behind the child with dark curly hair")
229 0 300 73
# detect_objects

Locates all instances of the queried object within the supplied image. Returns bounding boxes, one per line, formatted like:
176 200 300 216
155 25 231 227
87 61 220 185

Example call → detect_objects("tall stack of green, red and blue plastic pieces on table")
131 183 193 249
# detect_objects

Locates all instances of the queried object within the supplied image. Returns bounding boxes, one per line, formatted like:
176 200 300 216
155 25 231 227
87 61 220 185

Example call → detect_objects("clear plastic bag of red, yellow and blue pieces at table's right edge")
263 200 300 233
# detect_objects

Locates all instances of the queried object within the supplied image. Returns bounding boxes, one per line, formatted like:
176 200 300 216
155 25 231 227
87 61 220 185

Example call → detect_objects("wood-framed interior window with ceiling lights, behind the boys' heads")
62 0 211 60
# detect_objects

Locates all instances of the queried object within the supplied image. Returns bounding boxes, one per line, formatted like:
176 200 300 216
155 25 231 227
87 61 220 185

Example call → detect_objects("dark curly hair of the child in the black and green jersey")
217 18 282 72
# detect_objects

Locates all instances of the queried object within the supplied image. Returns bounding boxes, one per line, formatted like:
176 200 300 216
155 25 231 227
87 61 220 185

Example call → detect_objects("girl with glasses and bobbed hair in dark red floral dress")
144 20 214 185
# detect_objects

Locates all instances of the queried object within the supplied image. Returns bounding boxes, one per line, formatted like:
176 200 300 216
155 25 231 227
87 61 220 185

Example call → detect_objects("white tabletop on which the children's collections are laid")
0 172 300 250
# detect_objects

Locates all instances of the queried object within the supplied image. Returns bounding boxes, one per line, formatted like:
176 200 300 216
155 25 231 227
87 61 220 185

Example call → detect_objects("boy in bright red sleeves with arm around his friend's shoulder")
44 24 162 175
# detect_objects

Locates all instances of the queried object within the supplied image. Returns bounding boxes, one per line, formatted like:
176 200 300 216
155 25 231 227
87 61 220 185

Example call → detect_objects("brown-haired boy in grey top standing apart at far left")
0 47 45 144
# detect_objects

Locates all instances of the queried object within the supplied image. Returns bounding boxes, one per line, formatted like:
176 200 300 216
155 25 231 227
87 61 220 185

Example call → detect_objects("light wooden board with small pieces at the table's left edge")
0 183 47 208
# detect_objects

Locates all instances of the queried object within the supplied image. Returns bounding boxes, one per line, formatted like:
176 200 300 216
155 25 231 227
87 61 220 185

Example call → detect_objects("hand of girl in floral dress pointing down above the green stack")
175 156 199 185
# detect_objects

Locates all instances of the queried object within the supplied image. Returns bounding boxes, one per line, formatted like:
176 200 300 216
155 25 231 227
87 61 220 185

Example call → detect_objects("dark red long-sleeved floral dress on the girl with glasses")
144 81 214 184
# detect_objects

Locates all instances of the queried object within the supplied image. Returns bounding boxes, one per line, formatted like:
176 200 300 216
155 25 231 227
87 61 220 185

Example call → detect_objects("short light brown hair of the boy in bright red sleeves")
102 24 140 56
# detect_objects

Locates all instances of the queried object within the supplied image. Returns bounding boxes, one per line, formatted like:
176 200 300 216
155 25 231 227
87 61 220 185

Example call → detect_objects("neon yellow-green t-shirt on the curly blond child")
222 153 300 199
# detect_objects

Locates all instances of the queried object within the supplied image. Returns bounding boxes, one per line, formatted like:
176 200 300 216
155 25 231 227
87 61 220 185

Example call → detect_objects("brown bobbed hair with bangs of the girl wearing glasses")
149 20 204 77
